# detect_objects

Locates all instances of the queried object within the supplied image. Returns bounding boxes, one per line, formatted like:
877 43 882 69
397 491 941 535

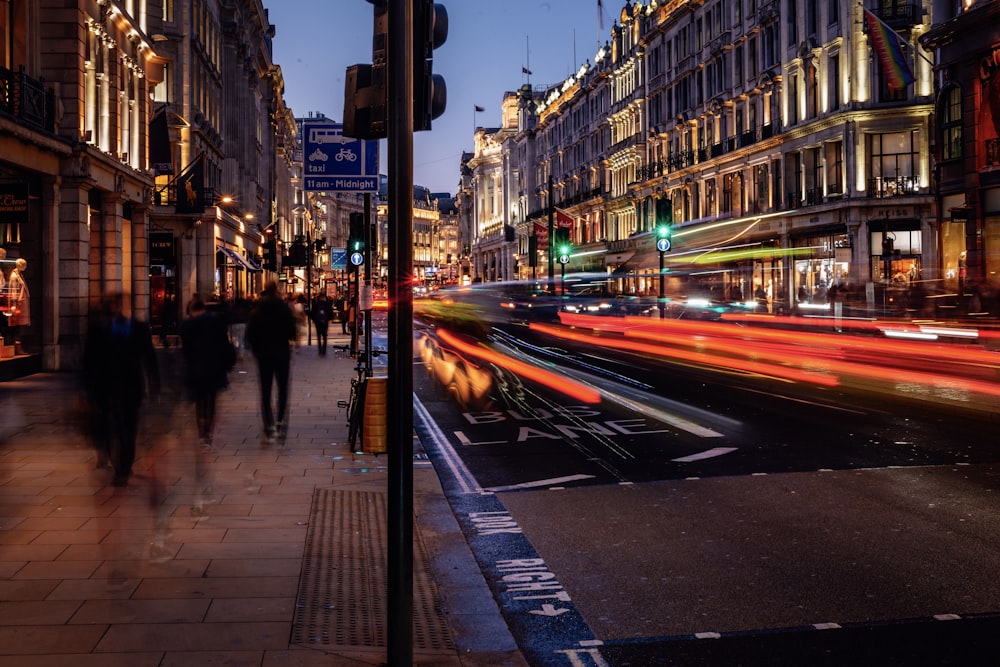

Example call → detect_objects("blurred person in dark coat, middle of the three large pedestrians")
180 296 236 448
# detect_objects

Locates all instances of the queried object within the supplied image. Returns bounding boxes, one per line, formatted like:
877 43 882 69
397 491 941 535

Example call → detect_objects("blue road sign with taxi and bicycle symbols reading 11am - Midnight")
302 123 378 192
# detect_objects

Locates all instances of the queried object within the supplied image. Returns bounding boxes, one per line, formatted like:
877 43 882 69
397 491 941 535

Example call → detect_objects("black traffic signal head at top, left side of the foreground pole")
344 0 389 139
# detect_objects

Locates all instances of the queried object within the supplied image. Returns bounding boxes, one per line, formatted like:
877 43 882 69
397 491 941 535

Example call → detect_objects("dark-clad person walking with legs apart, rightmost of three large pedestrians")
247 281 296 444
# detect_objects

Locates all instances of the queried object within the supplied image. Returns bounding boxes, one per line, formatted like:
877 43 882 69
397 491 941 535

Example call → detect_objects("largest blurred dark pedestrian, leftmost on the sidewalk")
83 294 160 486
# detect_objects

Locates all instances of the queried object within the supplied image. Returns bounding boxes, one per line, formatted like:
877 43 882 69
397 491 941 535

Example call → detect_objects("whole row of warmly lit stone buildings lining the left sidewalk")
0 0 295 377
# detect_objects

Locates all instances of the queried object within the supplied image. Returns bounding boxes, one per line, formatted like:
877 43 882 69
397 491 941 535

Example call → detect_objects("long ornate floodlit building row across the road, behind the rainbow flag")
469 0 944 312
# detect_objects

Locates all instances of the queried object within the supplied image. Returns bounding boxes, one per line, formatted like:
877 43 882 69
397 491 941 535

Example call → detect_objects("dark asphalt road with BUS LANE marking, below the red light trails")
414 320 1000 665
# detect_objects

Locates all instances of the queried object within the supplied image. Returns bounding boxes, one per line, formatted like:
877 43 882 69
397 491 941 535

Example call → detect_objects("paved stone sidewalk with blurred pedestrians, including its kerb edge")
0 336 526 667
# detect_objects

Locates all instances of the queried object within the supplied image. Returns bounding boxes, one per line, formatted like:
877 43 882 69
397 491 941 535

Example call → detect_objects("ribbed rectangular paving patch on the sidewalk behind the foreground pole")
292 489 454 650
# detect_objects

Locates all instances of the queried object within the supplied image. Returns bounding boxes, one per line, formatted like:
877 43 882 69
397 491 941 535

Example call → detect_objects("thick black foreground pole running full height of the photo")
386 0 414 665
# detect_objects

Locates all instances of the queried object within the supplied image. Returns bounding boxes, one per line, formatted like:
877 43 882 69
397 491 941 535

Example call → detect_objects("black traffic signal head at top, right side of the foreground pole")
413 0 448 132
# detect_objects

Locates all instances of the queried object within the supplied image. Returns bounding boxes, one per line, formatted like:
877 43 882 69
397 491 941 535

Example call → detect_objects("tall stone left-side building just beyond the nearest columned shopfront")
150 0 297 330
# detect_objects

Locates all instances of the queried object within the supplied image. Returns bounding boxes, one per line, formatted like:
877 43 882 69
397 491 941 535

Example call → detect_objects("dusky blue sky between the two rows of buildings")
264 0 612 194
